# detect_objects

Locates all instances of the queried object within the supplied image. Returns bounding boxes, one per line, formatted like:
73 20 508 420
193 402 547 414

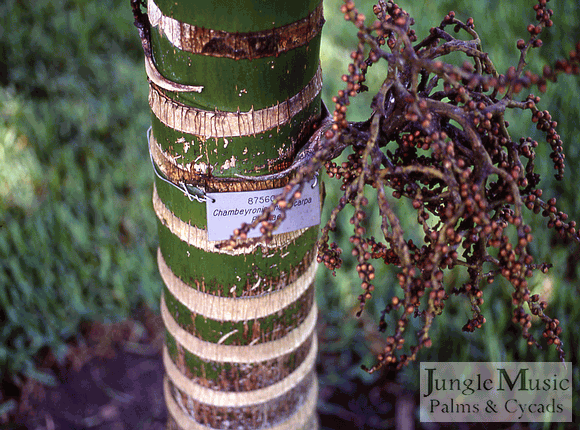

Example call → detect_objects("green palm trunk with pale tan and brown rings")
133 0 323 430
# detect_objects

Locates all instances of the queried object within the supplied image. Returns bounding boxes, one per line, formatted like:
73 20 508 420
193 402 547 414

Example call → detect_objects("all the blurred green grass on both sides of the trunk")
0 0 580 420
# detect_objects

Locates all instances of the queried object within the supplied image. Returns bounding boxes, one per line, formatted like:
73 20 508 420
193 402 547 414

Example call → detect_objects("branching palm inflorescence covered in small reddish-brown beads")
232 0 580 372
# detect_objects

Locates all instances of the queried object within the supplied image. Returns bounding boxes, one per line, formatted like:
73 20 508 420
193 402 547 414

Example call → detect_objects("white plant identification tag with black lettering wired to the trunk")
207 180 320 240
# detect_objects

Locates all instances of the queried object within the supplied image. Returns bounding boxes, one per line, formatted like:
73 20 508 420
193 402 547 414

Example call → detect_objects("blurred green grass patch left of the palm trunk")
0 0 161 381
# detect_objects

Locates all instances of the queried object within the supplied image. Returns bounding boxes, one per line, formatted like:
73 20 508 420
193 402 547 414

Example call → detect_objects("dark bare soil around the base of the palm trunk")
0 310 572 430
